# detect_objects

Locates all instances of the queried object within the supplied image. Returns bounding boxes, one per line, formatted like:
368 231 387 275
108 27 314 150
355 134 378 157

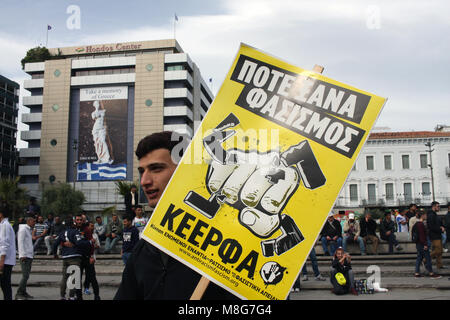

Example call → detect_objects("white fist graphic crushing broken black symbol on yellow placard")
184 113 326 256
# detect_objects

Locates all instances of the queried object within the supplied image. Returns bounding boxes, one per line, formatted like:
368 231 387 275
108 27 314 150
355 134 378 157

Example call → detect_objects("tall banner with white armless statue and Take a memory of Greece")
77 87 128 181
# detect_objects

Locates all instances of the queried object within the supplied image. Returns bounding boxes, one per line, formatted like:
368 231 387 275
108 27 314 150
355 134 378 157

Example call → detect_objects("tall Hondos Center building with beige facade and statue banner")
19 40 213 210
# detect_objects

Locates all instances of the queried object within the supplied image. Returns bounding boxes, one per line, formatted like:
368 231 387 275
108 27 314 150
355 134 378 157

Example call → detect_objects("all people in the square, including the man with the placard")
0 132 450 300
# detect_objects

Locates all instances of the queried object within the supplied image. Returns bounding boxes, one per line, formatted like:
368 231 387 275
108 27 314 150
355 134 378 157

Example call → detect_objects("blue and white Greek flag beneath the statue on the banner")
77 162 127 181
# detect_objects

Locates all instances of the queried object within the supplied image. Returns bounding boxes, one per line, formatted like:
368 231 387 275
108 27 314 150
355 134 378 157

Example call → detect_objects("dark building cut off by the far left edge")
0 75 20 178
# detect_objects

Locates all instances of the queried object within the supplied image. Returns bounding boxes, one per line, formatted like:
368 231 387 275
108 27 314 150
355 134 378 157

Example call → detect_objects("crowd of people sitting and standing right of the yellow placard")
293 201 450 294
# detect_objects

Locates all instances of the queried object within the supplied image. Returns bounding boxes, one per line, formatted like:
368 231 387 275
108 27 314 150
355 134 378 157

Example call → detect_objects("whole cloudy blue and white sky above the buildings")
0 0 450 148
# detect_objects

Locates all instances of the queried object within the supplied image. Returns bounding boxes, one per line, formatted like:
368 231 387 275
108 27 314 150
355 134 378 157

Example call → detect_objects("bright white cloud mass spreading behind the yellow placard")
0 0 450 141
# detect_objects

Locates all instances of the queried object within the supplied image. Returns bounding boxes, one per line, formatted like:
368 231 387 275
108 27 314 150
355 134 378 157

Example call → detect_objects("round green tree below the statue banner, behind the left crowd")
41 183 86 217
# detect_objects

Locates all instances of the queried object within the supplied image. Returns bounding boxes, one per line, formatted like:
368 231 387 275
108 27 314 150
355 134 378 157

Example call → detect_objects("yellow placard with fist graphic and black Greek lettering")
143 45 385 299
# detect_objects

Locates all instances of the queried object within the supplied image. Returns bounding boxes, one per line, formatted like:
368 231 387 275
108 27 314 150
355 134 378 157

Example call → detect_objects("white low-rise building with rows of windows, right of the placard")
335 130 450 209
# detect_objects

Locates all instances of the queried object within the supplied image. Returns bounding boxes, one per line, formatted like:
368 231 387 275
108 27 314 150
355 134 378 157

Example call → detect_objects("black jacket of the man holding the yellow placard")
114 239 237 300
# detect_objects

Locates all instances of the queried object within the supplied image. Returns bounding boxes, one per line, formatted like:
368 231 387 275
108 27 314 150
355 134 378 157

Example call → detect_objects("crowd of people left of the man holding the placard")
0 204 148 300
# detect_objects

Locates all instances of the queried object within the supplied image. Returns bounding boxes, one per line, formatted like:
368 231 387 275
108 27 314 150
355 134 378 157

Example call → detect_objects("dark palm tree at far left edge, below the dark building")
0 177 29 220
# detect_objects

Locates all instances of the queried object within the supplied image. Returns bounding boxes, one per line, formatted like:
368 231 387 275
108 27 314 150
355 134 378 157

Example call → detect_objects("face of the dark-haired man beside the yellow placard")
138 149 177 208
